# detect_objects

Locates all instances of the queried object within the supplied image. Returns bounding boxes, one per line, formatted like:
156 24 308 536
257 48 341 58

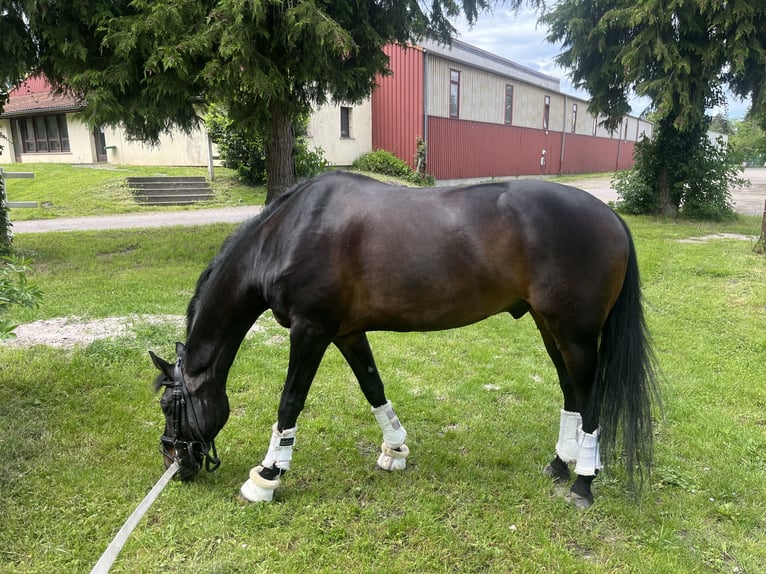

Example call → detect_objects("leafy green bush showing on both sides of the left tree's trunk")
205 106 330 185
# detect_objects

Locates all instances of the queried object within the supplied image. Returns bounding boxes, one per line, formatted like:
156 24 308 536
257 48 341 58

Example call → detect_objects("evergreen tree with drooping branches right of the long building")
543 0 766 215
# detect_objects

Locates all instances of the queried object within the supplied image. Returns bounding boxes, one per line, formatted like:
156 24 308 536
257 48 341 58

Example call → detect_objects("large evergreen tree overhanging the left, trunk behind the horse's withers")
0 0 539 200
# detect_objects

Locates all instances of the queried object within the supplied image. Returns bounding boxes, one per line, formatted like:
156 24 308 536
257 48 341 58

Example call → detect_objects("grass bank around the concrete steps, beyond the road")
0 163 266 221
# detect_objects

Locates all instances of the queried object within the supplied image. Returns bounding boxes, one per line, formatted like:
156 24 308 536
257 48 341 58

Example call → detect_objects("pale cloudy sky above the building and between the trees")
455 4 750 119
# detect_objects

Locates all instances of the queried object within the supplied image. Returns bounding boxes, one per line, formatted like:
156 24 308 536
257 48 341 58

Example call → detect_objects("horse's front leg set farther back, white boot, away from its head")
334 333 410 470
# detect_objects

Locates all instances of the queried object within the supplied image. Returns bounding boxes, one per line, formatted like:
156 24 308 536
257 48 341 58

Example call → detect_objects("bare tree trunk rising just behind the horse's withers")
266 100 295 204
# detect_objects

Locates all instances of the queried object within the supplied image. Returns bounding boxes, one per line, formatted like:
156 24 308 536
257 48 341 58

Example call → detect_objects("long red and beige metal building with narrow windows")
372 41 652 180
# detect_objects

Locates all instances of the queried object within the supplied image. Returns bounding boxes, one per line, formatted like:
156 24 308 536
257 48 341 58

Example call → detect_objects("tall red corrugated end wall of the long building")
372 45 424 168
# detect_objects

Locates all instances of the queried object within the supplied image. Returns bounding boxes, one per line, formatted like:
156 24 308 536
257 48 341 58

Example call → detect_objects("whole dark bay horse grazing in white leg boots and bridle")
151 172 655 506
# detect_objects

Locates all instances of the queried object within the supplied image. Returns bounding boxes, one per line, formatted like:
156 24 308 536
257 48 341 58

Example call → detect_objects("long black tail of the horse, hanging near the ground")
590 222 660 487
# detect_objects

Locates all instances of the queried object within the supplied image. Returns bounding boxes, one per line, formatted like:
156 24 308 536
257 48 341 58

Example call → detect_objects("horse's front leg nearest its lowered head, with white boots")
240 325 331 502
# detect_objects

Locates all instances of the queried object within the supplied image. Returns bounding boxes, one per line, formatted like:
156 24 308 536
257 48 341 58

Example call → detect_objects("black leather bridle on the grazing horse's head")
160 359 221 472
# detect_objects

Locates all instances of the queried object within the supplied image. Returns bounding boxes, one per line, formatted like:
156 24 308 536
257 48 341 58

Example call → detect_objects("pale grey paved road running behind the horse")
13 168 766 233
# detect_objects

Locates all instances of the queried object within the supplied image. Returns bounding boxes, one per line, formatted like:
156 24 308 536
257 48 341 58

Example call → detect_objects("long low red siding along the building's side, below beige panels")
427 117 634 179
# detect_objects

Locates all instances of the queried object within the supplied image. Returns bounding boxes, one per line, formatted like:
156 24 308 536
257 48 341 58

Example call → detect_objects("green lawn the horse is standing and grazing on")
0 207 766 574
